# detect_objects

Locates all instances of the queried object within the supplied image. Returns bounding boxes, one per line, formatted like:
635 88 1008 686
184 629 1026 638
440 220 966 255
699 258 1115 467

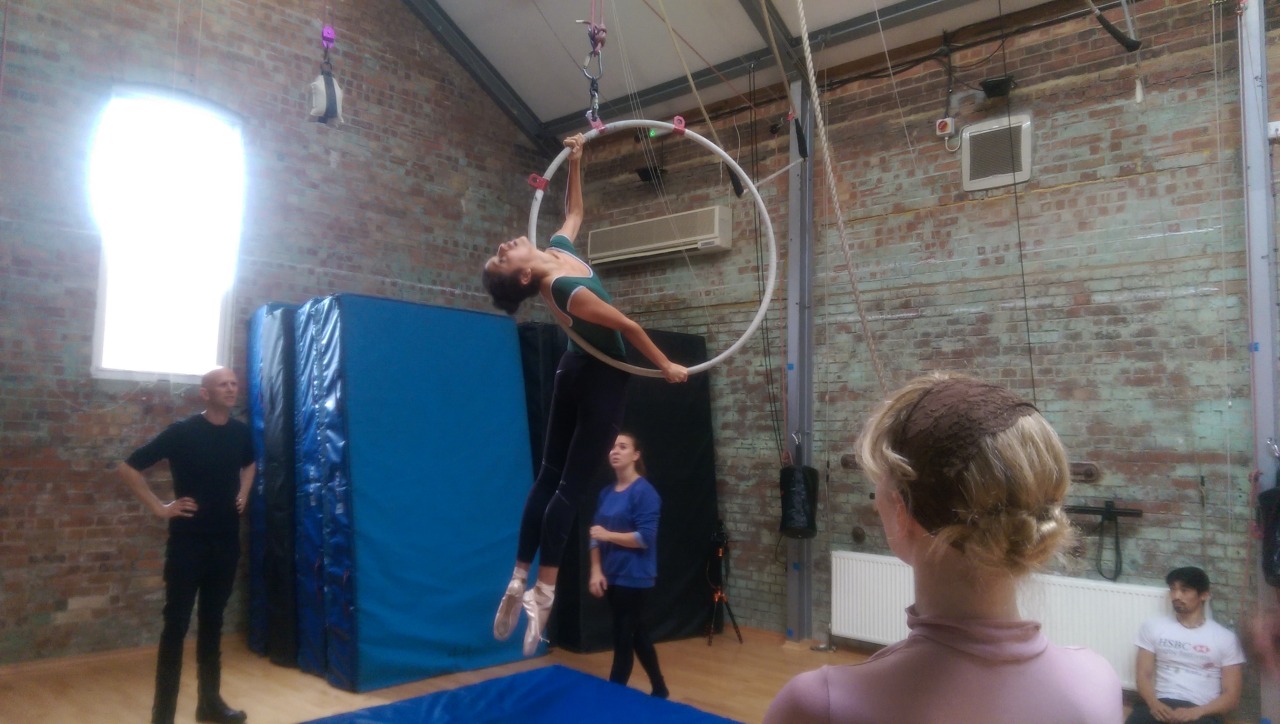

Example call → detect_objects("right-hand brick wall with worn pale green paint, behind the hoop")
588 3 1280 660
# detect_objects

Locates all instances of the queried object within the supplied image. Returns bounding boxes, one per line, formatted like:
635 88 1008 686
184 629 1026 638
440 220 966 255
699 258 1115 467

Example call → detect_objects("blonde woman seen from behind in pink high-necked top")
765 374 1124 724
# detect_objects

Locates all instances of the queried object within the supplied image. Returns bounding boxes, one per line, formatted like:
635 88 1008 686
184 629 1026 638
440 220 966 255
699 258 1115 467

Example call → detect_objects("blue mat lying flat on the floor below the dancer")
310 665 733 724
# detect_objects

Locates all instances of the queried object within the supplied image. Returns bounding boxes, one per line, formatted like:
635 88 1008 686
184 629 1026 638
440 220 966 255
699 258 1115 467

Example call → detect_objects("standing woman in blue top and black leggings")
590 432 667 698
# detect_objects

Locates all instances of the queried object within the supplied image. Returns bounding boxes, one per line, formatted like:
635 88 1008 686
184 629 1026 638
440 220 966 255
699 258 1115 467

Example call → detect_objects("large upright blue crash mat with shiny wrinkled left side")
294 294 534 691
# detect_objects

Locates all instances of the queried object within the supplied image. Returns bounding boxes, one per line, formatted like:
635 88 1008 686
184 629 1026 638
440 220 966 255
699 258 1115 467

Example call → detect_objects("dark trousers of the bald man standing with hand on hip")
151 531 239 721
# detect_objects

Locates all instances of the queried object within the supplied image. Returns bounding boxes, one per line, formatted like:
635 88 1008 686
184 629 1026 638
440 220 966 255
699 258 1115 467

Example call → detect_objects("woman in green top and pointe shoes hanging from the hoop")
481 134 689 656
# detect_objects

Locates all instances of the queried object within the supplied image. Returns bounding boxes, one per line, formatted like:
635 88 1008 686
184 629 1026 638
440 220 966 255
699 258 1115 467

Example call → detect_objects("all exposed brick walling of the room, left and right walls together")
0 0 1280 711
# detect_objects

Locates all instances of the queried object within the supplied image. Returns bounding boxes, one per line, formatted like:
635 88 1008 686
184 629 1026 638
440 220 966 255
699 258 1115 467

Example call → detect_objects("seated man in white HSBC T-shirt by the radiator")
1126 567 1244 724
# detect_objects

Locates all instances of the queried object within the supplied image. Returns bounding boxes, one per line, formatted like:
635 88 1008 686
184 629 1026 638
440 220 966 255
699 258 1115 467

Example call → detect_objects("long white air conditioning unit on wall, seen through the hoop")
586 206 733 264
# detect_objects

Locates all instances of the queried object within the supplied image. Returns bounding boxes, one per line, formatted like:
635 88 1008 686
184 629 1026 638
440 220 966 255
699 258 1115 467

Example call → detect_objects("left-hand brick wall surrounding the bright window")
0 0 543 663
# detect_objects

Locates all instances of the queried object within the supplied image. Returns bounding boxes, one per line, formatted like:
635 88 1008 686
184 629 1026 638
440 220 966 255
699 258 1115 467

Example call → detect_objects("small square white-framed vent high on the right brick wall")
960 114 1032 191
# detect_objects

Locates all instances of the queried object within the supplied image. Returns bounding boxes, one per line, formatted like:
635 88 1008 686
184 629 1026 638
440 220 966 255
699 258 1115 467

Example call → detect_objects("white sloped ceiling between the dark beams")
406 0 1049 146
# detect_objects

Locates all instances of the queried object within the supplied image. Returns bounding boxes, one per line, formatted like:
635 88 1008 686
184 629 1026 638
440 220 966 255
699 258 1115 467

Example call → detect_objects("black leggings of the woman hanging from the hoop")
516 352 631 568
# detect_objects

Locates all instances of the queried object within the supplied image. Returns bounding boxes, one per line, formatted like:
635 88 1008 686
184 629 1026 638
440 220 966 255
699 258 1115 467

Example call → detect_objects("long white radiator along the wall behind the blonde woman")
831 550 1171 689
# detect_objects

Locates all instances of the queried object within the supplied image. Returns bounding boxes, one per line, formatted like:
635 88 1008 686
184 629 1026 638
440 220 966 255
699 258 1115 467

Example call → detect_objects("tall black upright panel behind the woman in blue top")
520 322 718 652
